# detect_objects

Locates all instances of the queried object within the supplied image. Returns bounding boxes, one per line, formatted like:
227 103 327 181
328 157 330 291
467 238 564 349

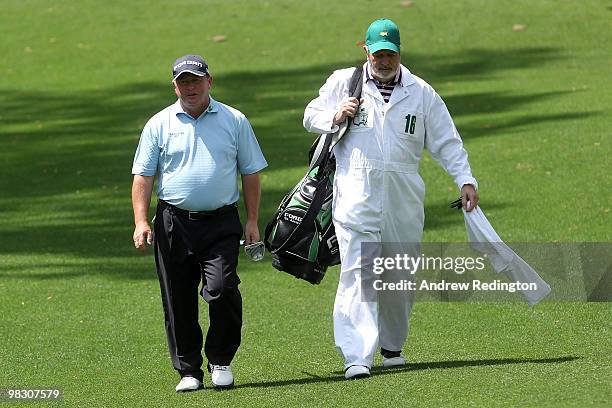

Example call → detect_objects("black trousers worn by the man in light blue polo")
154 201 242 380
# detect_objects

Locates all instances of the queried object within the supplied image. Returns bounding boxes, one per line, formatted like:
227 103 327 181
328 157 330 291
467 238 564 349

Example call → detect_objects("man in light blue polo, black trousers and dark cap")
132 55 267 392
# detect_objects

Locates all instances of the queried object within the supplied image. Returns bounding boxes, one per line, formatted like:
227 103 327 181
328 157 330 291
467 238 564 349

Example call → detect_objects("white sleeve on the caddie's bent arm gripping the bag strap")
303 68 353 134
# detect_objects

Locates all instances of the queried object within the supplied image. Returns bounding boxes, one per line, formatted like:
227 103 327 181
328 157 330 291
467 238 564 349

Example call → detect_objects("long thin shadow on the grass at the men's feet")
235 356 580 388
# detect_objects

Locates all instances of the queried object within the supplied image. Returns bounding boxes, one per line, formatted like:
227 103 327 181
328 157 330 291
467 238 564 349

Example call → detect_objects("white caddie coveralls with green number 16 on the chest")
304 64 477 368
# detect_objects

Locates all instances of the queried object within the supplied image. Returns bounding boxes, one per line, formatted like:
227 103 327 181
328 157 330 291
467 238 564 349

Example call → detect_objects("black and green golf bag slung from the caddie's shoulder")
264 66 363 285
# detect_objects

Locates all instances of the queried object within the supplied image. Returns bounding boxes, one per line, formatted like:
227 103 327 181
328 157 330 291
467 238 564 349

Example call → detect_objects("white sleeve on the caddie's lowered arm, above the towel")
425 89 478 189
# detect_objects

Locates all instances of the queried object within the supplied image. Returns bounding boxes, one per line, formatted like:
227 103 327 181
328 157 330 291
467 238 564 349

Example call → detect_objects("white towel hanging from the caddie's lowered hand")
463 207 550 306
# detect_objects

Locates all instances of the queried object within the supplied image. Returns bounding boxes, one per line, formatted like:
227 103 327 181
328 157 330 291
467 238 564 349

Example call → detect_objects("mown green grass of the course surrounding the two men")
0 0 612 407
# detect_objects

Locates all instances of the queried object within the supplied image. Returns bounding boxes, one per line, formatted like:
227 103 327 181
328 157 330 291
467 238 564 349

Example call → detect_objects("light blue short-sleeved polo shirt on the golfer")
132 97 268 211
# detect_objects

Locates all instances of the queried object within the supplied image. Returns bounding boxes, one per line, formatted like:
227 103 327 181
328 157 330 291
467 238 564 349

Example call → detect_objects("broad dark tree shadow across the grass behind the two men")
0 48 595 279
